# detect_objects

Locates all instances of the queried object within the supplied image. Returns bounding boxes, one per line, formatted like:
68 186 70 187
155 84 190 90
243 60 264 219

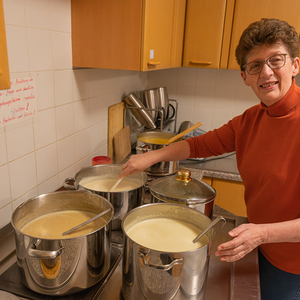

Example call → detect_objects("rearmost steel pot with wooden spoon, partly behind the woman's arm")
136 131 179 176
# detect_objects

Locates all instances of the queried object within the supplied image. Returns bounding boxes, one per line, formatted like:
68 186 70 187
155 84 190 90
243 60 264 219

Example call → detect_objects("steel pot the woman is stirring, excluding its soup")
64 164 148 230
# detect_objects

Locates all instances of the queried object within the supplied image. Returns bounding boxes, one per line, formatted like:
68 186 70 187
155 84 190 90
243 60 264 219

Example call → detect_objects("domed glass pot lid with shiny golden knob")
149 169 216 204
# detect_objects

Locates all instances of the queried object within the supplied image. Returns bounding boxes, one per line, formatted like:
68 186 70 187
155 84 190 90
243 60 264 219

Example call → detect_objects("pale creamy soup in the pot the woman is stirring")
79 176 140 192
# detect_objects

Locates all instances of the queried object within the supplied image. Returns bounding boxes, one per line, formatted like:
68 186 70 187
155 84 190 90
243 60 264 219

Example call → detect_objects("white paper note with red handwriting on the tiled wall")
0 77 37 127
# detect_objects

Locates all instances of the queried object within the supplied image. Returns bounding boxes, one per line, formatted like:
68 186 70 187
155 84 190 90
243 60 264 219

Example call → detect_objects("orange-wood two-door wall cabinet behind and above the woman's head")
183 0 300 70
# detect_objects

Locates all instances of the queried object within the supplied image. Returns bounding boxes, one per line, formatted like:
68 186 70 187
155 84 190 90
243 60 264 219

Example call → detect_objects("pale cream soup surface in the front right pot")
126 218 209 252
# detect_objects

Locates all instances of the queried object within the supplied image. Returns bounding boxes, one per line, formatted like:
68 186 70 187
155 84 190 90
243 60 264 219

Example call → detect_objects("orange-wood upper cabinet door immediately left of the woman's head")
183 0 234 69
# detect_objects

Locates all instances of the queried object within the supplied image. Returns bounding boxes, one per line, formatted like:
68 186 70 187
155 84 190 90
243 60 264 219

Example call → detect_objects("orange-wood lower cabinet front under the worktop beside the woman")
202 177 247 217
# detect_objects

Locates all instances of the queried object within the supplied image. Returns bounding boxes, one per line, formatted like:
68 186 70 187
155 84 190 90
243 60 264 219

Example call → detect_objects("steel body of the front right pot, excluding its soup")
122 203 215 300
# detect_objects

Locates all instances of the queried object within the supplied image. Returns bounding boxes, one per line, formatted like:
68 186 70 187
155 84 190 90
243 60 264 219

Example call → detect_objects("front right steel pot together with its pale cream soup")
122 203 215 300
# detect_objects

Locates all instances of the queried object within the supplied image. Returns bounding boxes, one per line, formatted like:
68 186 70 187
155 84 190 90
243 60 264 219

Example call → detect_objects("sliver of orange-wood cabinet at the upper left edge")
0 0 10 90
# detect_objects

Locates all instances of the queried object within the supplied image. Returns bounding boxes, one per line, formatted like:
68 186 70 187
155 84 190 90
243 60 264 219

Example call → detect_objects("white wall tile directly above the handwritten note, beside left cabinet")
6 25 29 72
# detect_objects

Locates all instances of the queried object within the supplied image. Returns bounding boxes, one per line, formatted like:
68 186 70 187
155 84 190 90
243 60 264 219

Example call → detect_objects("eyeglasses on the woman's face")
243 53 287 75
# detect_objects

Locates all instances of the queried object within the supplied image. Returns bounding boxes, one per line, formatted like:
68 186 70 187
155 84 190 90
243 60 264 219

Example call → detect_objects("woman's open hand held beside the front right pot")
215 224 264 262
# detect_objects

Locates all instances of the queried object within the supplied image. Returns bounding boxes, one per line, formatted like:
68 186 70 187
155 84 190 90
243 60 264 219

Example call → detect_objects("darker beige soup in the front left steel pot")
21 210 106 239
